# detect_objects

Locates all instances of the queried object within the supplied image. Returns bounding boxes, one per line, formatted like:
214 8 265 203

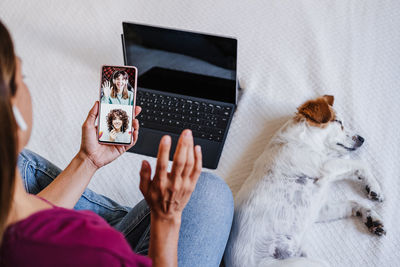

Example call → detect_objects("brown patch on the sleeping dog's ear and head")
295 95 335 128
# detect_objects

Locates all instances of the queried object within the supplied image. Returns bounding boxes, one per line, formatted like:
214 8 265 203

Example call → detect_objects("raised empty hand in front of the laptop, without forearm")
140 130 202 223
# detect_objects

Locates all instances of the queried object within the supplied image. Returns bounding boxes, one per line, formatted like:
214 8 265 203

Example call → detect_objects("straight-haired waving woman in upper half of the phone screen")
101 70 134 105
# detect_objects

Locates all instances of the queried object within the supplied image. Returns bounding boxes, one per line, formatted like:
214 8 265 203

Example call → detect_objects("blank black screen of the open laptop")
123 22 237 104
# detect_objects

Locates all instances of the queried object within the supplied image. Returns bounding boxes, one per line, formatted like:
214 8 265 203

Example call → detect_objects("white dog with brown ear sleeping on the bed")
225 95 386 267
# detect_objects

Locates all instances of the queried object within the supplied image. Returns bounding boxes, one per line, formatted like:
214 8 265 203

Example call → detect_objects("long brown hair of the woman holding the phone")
0 21 18 243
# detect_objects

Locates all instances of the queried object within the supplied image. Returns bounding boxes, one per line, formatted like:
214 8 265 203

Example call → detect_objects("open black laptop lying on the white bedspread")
121 22 238 169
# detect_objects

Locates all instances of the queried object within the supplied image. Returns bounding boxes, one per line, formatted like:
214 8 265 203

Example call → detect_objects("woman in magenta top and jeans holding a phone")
0 22 233 266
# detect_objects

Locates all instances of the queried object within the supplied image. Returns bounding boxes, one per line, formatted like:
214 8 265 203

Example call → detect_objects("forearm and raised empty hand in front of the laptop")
140 130 202 267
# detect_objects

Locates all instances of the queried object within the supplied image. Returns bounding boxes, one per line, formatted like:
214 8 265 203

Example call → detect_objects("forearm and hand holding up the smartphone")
38 101 141 209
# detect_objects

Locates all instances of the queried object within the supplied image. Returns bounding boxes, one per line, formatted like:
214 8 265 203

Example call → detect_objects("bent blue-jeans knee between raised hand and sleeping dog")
178 173 233 266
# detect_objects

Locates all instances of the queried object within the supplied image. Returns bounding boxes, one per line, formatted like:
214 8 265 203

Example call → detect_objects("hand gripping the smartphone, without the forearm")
79 101 142 171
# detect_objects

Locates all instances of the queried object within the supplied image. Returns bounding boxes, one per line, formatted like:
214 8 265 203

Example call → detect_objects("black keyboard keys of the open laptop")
136 90 232 142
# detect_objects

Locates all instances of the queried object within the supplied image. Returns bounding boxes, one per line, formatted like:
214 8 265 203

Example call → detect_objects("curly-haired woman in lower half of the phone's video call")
103 109 131 143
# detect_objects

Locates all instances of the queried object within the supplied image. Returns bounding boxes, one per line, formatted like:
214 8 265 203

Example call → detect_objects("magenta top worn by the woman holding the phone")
0 202 151 267
